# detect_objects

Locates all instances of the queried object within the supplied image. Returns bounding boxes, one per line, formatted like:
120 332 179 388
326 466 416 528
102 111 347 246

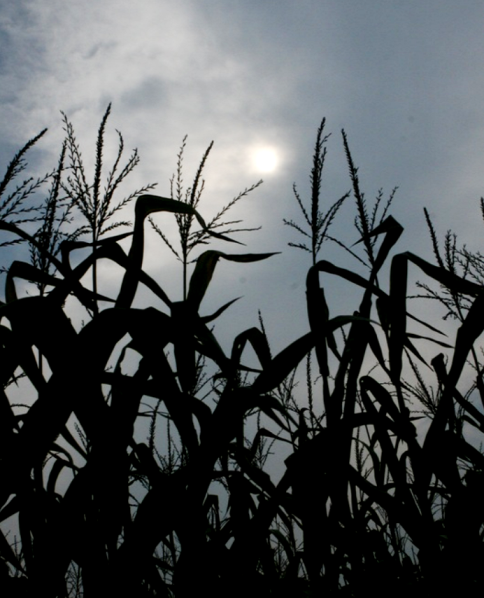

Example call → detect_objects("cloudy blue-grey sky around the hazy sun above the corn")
0 0 484 348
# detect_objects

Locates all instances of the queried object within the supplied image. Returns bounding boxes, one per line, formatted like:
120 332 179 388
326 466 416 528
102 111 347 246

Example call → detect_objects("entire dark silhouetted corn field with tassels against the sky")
0 107 484 598
